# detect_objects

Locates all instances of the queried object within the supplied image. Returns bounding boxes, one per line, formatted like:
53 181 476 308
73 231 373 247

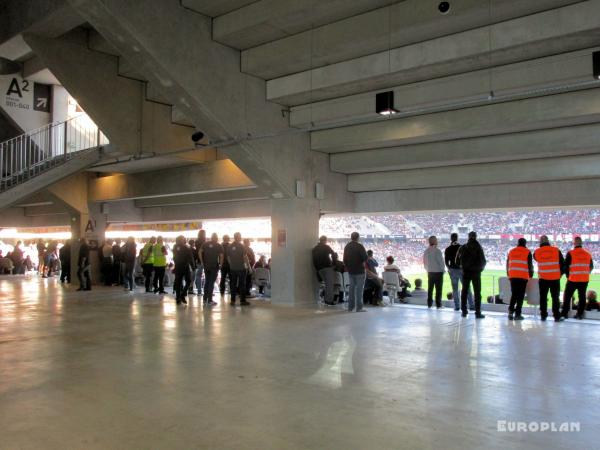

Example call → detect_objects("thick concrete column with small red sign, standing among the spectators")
271 199 319 306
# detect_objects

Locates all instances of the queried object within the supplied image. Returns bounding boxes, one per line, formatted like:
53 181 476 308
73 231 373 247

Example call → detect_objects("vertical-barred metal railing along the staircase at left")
0 114 109 192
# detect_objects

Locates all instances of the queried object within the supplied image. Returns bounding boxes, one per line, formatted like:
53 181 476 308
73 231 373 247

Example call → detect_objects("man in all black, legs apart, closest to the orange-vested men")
456 231 487 319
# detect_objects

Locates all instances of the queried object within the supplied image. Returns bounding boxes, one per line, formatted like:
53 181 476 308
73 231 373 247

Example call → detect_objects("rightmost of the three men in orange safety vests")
562 236 594 320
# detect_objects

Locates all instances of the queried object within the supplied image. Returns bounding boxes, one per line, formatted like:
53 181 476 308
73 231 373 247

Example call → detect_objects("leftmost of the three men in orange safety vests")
506 238 533 320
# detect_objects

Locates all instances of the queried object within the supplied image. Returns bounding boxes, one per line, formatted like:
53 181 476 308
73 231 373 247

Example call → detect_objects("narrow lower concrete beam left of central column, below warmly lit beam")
135 188 269 208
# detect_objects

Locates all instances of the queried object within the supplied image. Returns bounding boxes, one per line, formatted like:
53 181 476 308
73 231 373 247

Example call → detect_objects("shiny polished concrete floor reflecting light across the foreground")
0 277 600 450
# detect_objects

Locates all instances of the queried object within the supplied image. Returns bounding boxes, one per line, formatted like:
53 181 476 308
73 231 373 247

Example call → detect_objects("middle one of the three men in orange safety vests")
533 236 565 322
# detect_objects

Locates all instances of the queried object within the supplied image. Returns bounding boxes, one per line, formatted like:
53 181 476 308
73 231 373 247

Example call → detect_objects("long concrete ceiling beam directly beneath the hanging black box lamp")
311 89 600 153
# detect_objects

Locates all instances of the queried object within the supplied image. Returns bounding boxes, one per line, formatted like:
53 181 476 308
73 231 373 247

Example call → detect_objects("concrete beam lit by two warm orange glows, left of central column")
88 160 255 202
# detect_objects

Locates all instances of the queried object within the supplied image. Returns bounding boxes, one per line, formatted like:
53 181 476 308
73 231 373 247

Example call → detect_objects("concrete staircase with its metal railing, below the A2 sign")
0 114 109 209
